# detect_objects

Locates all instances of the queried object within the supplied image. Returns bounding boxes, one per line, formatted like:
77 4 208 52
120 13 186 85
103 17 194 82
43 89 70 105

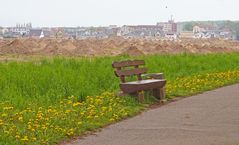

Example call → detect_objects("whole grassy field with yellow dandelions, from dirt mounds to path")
0 53 239 144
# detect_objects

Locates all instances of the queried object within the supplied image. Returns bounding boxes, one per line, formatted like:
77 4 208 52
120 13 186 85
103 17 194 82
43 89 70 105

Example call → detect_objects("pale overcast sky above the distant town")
0 0 239 27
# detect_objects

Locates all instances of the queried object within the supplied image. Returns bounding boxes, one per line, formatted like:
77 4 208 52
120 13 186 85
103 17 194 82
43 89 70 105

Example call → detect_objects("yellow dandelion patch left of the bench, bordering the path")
0 92 143 145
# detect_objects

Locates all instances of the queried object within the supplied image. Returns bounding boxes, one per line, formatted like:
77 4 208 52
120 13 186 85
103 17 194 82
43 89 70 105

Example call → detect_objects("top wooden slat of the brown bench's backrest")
112 60 145 68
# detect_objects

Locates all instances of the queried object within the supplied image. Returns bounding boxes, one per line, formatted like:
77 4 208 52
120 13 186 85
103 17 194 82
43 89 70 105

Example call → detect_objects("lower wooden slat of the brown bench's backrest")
115 68 147 77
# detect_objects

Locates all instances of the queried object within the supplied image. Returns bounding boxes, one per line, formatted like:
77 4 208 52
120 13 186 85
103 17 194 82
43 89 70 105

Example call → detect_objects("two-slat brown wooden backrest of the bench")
112 60 147 83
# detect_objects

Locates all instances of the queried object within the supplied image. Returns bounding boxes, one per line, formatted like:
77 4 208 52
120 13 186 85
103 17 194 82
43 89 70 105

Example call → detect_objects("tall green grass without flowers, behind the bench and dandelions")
0 53 239 108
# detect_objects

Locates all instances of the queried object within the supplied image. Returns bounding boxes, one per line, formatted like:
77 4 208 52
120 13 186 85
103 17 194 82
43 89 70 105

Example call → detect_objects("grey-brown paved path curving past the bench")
68 85 239 145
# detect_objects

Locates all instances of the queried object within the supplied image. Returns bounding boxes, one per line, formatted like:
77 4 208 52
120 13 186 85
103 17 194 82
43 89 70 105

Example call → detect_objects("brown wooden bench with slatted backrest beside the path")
112 60 166 101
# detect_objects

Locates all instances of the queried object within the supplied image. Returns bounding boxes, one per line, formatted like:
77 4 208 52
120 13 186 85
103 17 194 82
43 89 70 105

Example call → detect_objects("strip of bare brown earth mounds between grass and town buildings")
0 38 239 56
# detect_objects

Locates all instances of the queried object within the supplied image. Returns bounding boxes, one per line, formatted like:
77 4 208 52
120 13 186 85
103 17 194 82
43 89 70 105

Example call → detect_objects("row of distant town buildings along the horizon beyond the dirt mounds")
0 19 235 39
